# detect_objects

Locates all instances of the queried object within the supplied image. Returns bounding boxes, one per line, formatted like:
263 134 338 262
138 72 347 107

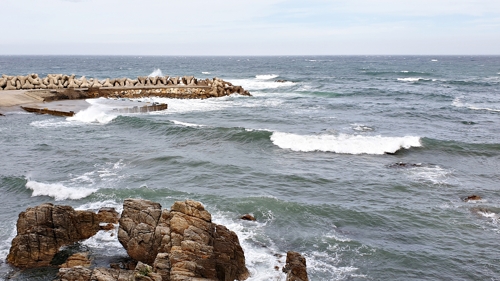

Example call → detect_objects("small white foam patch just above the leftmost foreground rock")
26 181 98 201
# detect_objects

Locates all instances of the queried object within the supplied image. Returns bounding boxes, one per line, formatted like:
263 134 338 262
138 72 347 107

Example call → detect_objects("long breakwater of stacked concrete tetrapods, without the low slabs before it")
0 74 250 101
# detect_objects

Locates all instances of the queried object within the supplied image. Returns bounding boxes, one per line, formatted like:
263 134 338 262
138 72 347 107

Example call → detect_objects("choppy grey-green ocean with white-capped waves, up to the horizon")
0 56 500 280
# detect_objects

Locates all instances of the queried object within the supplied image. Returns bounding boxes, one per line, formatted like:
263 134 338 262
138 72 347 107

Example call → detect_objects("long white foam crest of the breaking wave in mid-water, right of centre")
271 132 422 154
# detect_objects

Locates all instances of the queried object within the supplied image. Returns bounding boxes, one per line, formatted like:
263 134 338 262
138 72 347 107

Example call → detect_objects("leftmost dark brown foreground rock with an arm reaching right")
7 203 118 268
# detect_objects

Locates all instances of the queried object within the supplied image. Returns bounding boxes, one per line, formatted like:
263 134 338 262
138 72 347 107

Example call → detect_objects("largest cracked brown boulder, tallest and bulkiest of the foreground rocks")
118 199 249 281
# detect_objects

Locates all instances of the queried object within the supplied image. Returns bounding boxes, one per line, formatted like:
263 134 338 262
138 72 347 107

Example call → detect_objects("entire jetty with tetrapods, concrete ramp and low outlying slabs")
0 74 251 116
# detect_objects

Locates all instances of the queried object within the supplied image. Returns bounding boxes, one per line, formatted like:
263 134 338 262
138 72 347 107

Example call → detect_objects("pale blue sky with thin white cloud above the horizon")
0 0 500 56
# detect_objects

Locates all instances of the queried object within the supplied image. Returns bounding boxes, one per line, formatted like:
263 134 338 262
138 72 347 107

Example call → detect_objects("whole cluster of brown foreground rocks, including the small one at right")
7 199 308 281
